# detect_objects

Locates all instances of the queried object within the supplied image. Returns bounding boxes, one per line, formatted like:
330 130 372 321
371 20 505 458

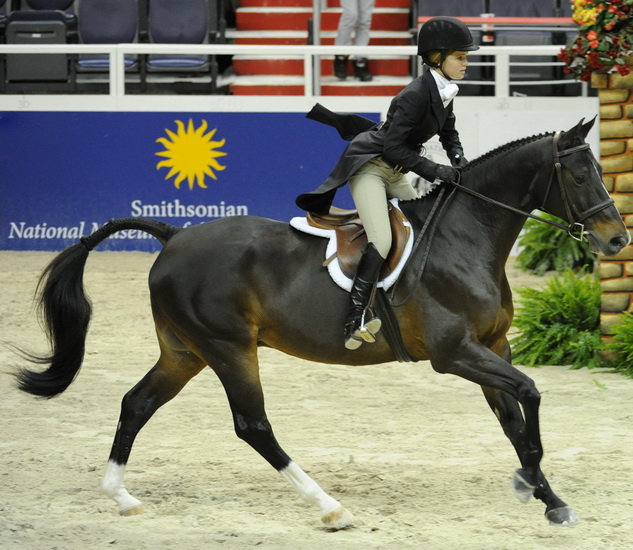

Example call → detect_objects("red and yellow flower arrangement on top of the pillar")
558 0 633 81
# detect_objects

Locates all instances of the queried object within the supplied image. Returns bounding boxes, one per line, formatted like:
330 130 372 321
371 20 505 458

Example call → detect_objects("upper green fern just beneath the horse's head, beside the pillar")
517 214 596 275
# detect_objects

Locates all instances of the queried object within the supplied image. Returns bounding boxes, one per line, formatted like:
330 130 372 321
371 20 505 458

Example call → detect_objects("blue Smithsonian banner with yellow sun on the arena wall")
0 111 378 251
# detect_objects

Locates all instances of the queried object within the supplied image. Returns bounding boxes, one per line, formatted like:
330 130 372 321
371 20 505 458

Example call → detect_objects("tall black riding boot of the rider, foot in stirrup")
345 243 384 349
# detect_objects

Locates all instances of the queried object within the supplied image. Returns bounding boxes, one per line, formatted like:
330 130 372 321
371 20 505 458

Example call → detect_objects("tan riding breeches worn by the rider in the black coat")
349 158 418 258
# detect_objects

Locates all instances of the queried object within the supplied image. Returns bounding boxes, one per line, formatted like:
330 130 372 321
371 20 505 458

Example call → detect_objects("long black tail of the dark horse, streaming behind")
15 218 180 398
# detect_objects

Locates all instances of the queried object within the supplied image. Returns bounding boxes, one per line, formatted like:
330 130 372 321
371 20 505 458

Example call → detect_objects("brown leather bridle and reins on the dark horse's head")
449 132 614 241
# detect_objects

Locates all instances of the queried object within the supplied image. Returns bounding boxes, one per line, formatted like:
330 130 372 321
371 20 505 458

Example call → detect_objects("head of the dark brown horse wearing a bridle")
542 118 631 256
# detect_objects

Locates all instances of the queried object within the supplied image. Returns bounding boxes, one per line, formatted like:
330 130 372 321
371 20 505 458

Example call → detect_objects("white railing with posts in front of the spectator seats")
0 44 587 98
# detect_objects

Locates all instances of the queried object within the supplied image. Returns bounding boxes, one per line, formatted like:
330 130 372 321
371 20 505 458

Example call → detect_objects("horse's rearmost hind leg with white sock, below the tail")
101 350 206 516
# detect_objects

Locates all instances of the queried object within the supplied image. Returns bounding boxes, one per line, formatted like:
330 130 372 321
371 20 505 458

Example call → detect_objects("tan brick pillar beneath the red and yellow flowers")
591 73 633 339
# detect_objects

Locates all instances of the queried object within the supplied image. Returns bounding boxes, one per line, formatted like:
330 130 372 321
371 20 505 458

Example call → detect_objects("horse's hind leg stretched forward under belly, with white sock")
211 353 354 529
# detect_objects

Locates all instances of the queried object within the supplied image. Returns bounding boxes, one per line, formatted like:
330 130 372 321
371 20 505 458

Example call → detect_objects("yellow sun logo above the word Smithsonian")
155 119 227 189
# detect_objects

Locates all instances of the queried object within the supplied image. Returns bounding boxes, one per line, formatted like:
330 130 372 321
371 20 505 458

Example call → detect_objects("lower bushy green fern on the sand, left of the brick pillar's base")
510 269 602 368
